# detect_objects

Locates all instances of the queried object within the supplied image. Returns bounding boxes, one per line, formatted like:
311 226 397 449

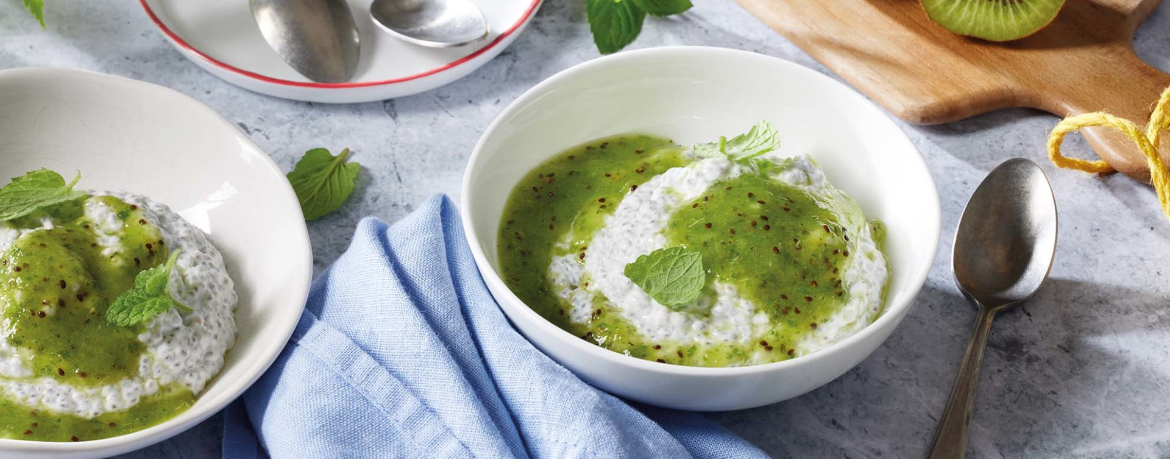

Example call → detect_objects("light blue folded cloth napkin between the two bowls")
223 197 766 459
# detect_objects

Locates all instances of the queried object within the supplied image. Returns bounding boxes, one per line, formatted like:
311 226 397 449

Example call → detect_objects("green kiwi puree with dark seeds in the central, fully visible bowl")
497 135 880 366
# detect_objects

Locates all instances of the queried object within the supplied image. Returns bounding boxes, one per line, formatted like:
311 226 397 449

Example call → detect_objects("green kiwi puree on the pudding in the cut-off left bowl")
0 196 194 441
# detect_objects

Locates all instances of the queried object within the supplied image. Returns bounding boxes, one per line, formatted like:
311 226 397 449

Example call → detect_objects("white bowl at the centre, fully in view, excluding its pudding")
461 47 940 411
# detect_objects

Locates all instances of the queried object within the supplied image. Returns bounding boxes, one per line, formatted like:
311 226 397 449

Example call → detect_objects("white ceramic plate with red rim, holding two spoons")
139 0 542 103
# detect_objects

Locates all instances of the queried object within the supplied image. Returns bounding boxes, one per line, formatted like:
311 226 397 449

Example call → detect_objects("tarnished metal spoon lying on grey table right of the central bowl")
929 158 1057 459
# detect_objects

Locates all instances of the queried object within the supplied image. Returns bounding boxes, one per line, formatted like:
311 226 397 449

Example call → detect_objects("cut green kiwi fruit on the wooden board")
922 0 1065 41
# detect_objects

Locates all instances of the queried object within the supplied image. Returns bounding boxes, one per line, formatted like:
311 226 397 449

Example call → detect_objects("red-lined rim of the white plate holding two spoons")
138 0 541 89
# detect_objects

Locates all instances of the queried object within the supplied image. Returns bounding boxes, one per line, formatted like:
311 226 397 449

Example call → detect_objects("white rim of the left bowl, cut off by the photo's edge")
0 67 312 453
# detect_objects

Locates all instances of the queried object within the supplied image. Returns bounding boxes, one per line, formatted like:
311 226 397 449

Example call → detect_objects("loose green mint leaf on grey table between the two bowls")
288 149 362 220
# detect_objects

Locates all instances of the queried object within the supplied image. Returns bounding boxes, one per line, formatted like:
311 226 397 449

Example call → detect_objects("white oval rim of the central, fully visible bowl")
460 46 942 376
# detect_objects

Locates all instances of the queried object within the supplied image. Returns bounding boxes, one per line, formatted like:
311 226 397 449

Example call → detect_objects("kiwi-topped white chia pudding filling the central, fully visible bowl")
498 128 889 366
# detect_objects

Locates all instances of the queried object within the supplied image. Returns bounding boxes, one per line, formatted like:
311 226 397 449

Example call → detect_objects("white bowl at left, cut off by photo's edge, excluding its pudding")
0 69 312 459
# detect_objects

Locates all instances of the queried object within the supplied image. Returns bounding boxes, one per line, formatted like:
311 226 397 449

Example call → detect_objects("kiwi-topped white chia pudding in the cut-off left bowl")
0 192 236 441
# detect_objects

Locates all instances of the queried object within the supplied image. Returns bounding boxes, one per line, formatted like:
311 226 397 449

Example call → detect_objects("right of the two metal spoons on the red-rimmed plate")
370 0 489 48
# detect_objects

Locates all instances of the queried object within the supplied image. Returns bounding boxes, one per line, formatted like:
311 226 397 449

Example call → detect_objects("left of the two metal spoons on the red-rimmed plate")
250 0 362 83
